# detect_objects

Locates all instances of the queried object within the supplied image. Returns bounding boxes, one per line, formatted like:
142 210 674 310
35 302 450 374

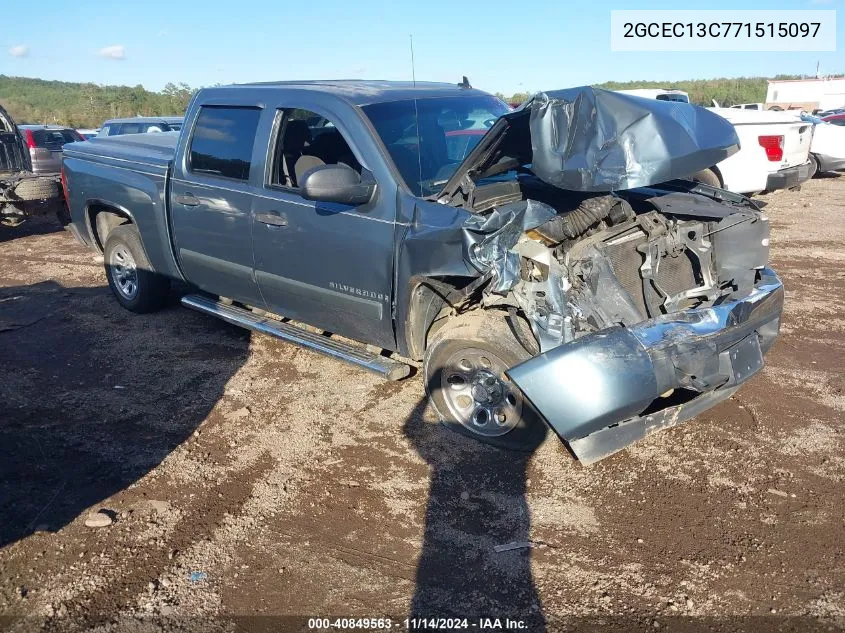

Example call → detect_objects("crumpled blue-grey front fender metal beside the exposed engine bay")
463 200 557 293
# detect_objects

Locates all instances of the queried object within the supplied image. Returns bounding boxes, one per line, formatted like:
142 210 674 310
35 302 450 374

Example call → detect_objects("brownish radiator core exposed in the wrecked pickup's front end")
606 236 699 319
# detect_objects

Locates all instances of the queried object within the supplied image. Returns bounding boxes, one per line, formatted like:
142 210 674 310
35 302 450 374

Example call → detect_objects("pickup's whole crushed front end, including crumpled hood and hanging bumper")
438 88 783 463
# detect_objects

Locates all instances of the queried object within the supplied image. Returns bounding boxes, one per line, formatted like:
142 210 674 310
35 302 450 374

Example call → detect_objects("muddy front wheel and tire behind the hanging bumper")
423 310 546 451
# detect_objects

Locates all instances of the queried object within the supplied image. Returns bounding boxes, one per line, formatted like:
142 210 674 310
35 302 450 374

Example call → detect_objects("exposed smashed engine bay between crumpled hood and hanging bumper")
464 178 769 351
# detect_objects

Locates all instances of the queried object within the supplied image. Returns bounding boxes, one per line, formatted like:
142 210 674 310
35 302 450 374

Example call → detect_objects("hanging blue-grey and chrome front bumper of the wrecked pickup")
507 268 783 464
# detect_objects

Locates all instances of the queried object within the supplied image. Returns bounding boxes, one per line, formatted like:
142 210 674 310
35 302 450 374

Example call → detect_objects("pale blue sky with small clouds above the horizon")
0 0 845 94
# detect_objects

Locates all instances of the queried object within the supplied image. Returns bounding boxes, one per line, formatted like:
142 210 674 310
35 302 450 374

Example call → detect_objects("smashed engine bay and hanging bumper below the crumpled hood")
484 186 783 464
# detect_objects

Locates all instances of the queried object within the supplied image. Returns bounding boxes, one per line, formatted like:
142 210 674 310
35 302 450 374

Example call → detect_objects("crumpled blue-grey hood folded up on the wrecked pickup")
528 87 739 191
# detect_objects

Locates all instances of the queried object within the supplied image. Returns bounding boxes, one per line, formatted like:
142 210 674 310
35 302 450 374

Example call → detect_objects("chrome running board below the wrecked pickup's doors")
182 295 411 380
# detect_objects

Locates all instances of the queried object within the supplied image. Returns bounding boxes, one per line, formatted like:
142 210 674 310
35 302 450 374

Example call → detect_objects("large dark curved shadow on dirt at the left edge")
0 282 249 547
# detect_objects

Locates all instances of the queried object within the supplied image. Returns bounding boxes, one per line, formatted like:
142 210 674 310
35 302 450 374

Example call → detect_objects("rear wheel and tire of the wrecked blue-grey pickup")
103 224 170 313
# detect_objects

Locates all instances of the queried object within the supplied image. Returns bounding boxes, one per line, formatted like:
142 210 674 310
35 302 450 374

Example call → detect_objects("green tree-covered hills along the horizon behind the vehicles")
0 75 832 128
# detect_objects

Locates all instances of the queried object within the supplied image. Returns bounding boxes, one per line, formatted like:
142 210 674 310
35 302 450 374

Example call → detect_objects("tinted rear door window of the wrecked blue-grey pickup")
188 106 261 181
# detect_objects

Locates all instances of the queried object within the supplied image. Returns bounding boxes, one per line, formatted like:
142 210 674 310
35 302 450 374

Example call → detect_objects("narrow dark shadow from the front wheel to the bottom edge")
403 400 546 631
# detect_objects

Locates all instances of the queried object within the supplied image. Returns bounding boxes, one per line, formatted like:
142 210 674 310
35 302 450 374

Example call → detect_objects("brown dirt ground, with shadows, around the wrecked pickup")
0 177 845 632
